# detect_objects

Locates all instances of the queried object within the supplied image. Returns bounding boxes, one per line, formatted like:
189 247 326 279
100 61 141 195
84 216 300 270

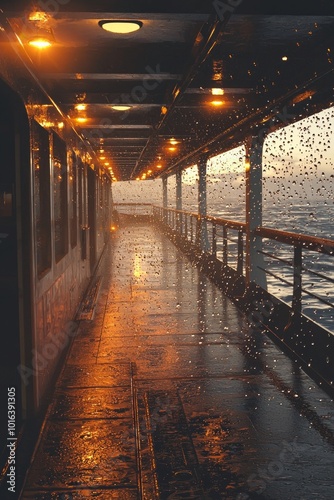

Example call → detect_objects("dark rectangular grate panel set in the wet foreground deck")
137 391 205 500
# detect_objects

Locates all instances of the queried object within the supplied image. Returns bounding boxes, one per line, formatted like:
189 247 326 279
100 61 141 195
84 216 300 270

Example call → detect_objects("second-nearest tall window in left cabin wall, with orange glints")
53 133 68 262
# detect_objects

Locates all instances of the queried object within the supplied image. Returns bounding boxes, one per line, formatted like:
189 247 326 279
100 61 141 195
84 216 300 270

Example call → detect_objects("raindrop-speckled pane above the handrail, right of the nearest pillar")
263 108 334 238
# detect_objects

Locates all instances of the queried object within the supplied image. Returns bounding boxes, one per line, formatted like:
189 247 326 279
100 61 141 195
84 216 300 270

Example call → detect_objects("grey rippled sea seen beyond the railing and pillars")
183 200 334 333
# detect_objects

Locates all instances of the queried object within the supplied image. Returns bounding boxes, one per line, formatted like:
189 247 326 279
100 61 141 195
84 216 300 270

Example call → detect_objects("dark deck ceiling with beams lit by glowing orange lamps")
1 0 334 180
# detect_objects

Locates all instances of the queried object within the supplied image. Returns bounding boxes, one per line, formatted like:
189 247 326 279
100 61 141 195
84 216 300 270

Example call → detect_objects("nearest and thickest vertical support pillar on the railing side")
246 137 267 290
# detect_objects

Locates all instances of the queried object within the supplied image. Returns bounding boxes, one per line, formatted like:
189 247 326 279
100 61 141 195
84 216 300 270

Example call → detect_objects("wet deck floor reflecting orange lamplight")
22 225 334 500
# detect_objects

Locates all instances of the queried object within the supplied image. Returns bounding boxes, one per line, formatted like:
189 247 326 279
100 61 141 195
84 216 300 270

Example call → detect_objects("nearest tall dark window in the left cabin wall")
32 121 51 277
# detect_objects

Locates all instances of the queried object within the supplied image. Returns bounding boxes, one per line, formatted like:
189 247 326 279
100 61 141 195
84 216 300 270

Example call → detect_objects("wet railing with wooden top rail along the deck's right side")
153 206 334 332
